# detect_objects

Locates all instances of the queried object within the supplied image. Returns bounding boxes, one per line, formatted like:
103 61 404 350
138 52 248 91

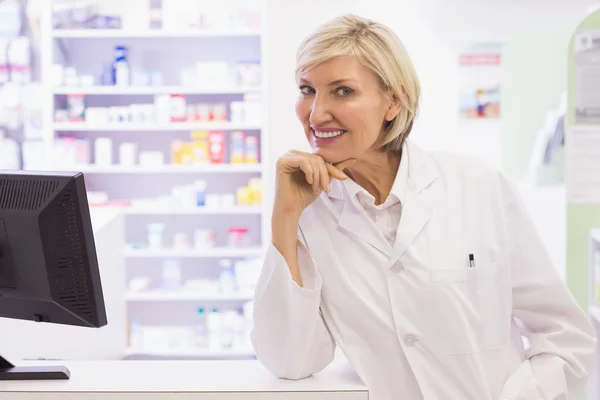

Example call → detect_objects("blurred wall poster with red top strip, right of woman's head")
458 44 502 119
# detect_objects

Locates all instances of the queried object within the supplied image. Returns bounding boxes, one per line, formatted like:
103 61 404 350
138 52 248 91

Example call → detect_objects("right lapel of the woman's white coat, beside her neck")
390 140 438 265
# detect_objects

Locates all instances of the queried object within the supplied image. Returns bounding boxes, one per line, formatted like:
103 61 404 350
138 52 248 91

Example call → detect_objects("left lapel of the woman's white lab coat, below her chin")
338 194 392 256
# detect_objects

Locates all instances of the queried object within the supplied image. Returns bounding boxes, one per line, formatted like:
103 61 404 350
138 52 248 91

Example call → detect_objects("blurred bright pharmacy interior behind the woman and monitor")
0 0 600 396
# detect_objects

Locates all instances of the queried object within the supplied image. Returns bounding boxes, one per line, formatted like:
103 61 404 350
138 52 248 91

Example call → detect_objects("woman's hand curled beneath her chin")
274 150 356 218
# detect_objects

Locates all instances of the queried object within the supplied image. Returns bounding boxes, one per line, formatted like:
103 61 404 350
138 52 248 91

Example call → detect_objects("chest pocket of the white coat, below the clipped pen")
431 264 511 354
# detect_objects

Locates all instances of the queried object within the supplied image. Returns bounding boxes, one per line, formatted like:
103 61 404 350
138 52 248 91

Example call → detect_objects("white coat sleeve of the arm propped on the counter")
251 230 335 379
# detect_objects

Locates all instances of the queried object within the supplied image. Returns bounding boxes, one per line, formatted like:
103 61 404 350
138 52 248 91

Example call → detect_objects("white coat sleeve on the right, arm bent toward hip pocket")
501 177 596 400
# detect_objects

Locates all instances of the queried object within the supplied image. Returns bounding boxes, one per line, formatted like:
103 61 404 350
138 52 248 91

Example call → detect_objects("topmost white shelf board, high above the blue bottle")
52 29 262 39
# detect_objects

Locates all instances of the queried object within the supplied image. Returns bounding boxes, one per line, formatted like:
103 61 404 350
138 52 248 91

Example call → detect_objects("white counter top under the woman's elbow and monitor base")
0 361 369 400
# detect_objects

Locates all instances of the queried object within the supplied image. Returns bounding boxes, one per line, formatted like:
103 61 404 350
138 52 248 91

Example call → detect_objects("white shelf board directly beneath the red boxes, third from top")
53 122 261 132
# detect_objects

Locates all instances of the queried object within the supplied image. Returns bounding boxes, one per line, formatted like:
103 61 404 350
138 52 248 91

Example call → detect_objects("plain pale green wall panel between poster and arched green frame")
501 25 573 180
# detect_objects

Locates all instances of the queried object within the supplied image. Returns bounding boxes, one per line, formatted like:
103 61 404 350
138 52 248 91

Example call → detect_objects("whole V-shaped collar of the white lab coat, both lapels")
328 141 438 260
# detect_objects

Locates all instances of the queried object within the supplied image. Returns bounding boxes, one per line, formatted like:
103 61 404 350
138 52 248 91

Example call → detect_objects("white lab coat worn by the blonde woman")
252 141 596 400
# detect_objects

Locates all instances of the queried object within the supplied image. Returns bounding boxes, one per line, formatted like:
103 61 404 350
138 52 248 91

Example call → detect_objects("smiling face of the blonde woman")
296 57 397 163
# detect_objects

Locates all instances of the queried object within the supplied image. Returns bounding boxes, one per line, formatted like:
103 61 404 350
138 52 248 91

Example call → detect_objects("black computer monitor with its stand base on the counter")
0 171 107 380
